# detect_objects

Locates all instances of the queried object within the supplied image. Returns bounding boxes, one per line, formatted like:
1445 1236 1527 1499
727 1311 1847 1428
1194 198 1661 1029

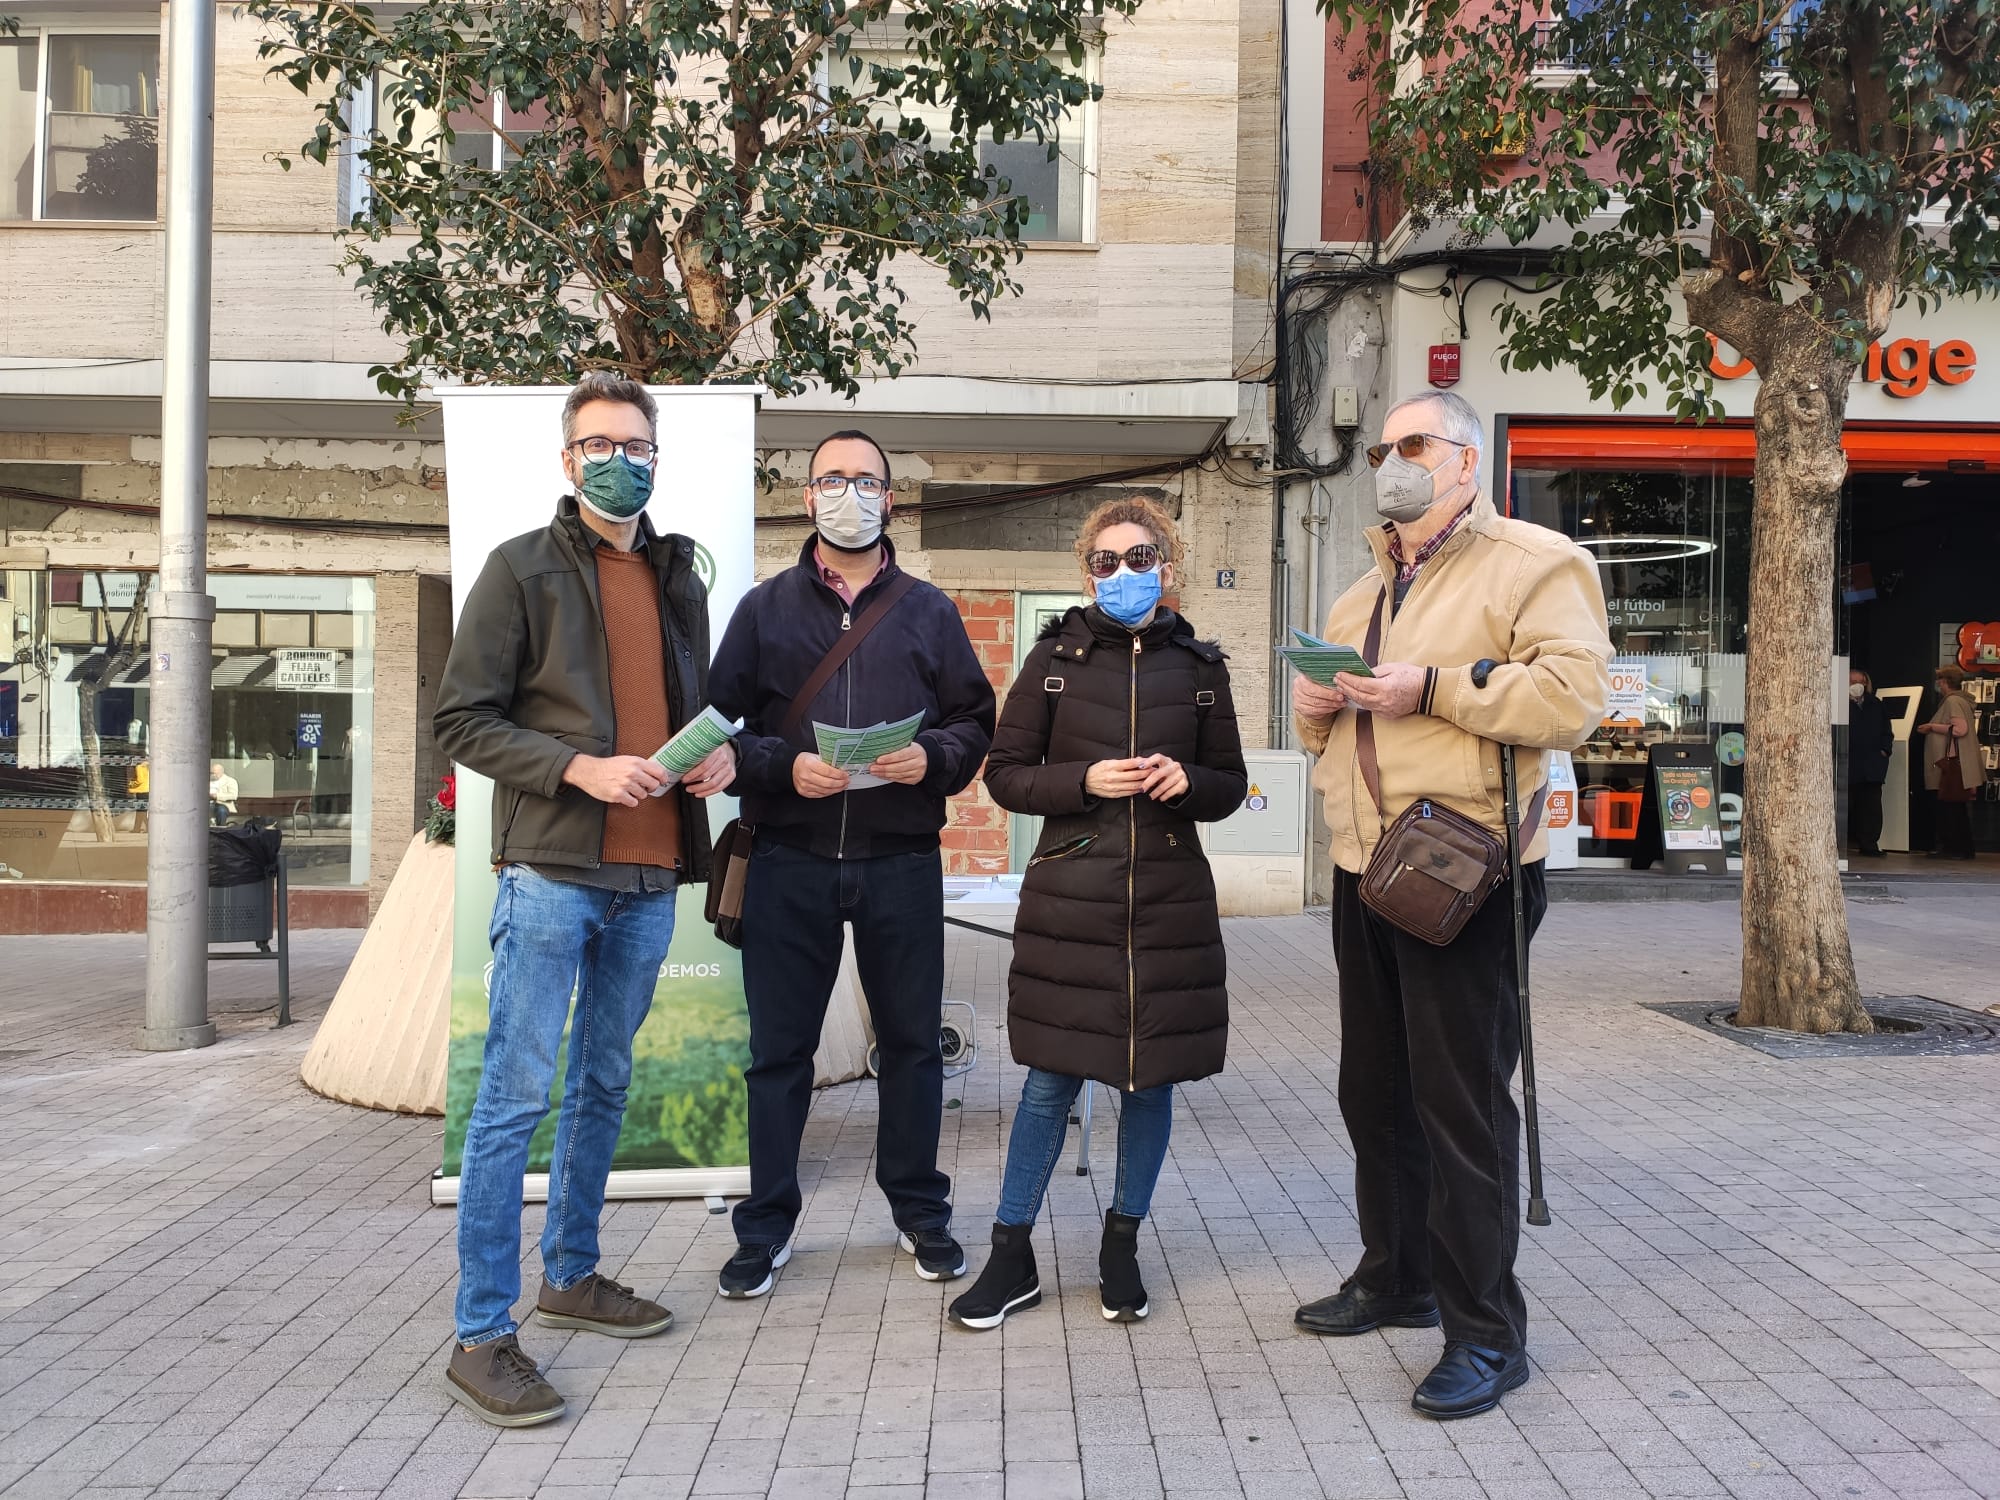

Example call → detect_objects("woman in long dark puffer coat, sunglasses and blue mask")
952 500 1248 1328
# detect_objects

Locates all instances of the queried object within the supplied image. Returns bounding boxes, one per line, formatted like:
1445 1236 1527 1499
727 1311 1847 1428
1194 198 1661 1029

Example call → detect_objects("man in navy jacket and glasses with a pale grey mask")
708 432 994 1298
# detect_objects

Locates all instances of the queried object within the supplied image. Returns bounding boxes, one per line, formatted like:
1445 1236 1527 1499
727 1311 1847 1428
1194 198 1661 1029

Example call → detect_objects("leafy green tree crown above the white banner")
248 0 1138 400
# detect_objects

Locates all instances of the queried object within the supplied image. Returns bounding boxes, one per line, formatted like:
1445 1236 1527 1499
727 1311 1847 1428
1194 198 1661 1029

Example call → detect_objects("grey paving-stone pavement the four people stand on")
0 894 2000 1500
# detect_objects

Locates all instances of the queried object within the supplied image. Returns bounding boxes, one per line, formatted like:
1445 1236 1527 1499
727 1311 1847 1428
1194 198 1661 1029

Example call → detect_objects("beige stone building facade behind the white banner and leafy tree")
0 0 1280 932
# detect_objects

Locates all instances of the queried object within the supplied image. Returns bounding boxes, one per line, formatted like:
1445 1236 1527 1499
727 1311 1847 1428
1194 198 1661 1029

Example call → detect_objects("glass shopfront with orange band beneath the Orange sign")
1504 424 2000 868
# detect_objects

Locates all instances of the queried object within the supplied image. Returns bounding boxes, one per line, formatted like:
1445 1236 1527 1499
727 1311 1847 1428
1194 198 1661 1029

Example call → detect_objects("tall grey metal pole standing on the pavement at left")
138 0 216 1052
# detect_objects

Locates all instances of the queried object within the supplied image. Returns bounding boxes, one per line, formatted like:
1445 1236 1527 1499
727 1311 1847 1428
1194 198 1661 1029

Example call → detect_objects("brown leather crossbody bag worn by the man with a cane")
1354 586 1548 948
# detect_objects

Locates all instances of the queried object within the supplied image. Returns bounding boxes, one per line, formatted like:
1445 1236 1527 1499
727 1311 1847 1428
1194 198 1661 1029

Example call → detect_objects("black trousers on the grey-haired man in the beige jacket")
1334 862 1548 1350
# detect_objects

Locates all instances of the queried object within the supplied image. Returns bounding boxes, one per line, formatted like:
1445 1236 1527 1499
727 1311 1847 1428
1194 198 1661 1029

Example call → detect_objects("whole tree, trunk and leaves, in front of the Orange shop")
1320 0 2000 1032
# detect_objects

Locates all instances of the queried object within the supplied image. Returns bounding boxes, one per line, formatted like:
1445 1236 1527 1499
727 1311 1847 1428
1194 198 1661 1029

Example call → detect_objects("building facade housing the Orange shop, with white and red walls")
1272 0 2000 890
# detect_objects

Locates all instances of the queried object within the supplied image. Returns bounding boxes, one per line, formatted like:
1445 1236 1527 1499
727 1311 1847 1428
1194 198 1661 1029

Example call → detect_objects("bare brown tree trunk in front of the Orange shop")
1738 348 1874 1034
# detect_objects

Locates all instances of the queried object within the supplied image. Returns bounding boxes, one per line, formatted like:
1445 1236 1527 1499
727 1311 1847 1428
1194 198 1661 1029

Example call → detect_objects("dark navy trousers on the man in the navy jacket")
734 838 952 1246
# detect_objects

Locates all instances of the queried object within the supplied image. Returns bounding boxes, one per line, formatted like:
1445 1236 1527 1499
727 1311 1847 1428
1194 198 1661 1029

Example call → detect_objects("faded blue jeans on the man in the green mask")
456 864 674 1344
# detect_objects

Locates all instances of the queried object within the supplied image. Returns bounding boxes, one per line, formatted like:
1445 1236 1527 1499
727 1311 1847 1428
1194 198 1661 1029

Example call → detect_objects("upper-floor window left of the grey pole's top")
0 30 160 222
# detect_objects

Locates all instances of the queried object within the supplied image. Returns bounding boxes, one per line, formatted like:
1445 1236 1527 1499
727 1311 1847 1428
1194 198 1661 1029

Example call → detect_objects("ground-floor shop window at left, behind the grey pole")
0 570 374 886
